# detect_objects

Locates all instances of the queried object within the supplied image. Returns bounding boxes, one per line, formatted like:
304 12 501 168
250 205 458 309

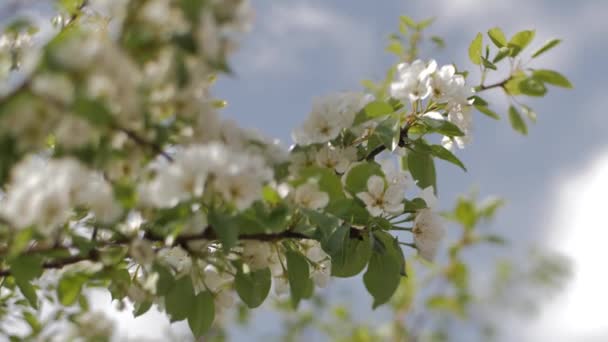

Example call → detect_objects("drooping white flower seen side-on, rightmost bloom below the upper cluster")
412 209 445 261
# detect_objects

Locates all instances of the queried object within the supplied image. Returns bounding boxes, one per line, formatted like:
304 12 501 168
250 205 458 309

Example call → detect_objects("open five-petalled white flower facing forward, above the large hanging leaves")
357 175 404 216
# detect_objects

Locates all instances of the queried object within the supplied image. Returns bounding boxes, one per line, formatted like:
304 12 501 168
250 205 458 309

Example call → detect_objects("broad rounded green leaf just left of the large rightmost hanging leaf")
322 225 372 278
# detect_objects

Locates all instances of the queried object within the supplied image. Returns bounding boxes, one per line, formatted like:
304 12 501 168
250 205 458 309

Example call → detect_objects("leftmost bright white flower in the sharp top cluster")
391 60 437 102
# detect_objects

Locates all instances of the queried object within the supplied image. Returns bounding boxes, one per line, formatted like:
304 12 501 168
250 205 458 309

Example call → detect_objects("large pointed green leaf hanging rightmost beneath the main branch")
363 232 405 309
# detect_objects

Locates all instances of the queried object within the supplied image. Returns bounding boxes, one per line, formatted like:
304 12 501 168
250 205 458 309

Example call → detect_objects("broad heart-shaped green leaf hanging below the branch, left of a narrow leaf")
234 264 271 308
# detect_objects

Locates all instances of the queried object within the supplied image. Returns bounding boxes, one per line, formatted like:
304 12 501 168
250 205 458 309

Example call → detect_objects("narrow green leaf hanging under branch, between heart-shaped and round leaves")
285 250 313 308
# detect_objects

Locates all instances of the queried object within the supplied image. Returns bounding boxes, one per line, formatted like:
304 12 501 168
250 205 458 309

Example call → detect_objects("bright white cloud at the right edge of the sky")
527 151 608 342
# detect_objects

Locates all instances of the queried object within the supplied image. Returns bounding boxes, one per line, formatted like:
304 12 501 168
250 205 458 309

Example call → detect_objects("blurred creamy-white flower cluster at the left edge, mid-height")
0 157 121 236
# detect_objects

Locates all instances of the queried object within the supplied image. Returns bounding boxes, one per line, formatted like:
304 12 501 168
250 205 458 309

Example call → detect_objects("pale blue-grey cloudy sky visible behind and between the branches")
0 0 608 342
